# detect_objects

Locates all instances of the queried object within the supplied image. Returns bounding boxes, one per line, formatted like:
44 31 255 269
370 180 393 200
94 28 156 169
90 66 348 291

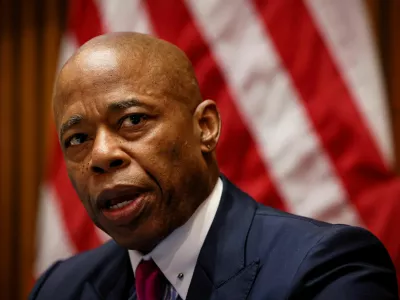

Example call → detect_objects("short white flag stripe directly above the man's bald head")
96 0 153 33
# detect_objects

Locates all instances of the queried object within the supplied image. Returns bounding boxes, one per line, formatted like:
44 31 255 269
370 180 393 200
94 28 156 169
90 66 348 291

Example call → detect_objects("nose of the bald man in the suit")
90 130 130 174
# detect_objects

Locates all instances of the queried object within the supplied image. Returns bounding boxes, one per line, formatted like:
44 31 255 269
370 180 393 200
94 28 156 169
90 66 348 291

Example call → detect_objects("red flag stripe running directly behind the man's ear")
147 0 285 210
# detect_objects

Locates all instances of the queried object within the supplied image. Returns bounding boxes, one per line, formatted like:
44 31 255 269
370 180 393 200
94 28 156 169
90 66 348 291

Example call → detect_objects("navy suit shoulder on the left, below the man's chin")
29 241 126 299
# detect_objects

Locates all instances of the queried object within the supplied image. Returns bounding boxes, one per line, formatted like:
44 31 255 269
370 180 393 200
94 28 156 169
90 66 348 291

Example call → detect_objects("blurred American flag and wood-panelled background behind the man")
0 0 400 299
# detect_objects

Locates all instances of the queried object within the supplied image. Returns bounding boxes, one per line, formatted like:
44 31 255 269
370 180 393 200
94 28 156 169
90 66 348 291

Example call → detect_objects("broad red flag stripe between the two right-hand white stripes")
253 0 400 270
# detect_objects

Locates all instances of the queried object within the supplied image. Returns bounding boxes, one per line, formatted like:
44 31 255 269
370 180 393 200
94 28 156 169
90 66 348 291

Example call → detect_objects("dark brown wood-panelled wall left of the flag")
0 0 66 300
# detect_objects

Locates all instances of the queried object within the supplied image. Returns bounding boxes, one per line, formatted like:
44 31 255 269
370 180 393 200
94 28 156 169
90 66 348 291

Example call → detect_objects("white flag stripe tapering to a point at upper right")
305 0 394 165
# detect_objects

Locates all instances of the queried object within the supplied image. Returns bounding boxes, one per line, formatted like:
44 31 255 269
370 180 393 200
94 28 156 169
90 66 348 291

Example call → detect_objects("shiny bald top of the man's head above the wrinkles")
53 32 202 125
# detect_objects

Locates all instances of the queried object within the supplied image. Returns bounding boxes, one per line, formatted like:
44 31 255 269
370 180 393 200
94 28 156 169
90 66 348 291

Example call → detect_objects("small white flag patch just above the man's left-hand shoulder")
34 185 76 278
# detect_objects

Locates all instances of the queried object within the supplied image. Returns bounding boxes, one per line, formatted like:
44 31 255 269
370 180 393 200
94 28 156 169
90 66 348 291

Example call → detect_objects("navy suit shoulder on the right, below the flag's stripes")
223 177 390 265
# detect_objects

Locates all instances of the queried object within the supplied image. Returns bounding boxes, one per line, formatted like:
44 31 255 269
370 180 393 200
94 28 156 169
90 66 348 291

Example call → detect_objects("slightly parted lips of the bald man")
96 186 148 225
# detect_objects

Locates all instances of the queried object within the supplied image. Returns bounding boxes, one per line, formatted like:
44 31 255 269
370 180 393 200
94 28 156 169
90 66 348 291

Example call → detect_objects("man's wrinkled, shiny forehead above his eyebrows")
54 49 170 124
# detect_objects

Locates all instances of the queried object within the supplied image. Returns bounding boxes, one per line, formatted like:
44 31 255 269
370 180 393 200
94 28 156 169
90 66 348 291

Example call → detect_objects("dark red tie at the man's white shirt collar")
135 259 166 300
